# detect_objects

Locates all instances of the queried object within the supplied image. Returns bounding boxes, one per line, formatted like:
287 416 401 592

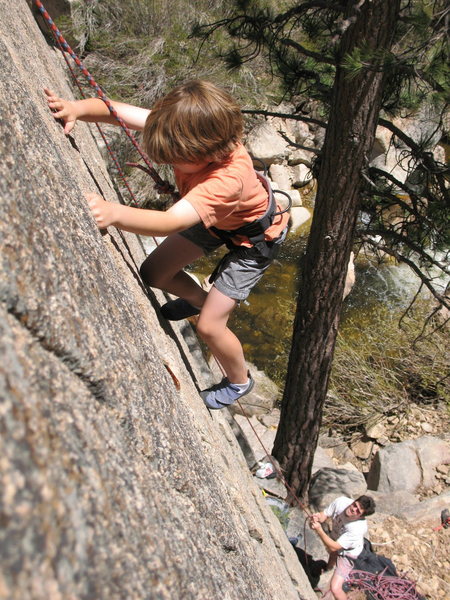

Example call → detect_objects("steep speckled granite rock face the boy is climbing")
0 0 315 600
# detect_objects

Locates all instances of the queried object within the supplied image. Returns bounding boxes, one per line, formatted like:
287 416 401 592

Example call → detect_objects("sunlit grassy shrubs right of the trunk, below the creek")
323 302 450 433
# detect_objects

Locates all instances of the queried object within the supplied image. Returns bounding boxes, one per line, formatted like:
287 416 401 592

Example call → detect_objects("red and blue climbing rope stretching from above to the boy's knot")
33 0 179 200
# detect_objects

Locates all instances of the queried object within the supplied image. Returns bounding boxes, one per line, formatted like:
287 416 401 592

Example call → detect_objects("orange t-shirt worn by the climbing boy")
174 144 289 246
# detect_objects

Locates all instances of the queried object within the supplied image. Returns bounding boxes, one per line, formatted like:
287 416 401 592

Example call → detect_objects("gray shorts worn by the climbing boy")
179 223 287 300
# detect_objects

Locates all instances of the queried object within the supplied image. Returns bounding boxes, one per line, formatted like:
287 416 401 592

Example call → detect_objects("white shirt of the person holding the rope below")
324 496 367 558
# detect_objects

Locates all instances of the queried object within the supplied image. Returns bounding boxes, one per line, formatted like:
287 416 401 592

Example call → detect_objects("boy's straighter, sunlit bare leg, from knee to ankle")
197 286 248 384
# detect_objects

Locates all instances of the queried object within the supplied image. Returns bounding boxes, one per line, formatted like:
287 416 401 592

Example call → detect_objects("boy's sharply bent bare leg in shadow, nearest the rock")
140 233 207 308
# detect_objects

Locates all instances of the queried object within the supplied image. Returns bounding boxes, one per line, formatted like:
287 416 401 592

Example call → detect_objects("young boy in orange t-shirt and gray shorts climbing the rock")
45 80 289 409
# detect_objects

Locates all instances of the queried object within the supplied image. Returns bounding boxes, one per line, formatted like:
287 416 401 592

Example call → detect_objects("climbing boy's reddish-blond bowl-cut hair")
144 79 243 164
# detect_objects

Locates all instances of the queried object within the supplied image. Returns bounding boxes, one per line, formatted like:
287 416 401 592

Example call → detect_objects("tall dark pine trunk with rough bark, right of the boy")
273 0 400 499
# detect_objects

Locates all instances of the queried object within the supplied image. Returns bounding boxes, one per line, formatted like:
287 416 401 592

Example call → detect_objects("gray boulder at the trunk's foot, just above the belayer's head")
309 468 367 511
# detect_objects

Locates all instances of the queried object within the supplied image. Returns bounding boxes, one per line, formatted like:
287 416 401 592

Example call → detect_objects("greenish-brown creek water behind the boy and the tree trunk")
179 221 436 386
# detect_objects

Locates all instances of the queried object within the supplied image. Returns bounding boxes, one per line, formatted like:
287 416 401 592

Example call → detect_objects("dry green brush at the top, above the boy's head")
63 0 276 106
